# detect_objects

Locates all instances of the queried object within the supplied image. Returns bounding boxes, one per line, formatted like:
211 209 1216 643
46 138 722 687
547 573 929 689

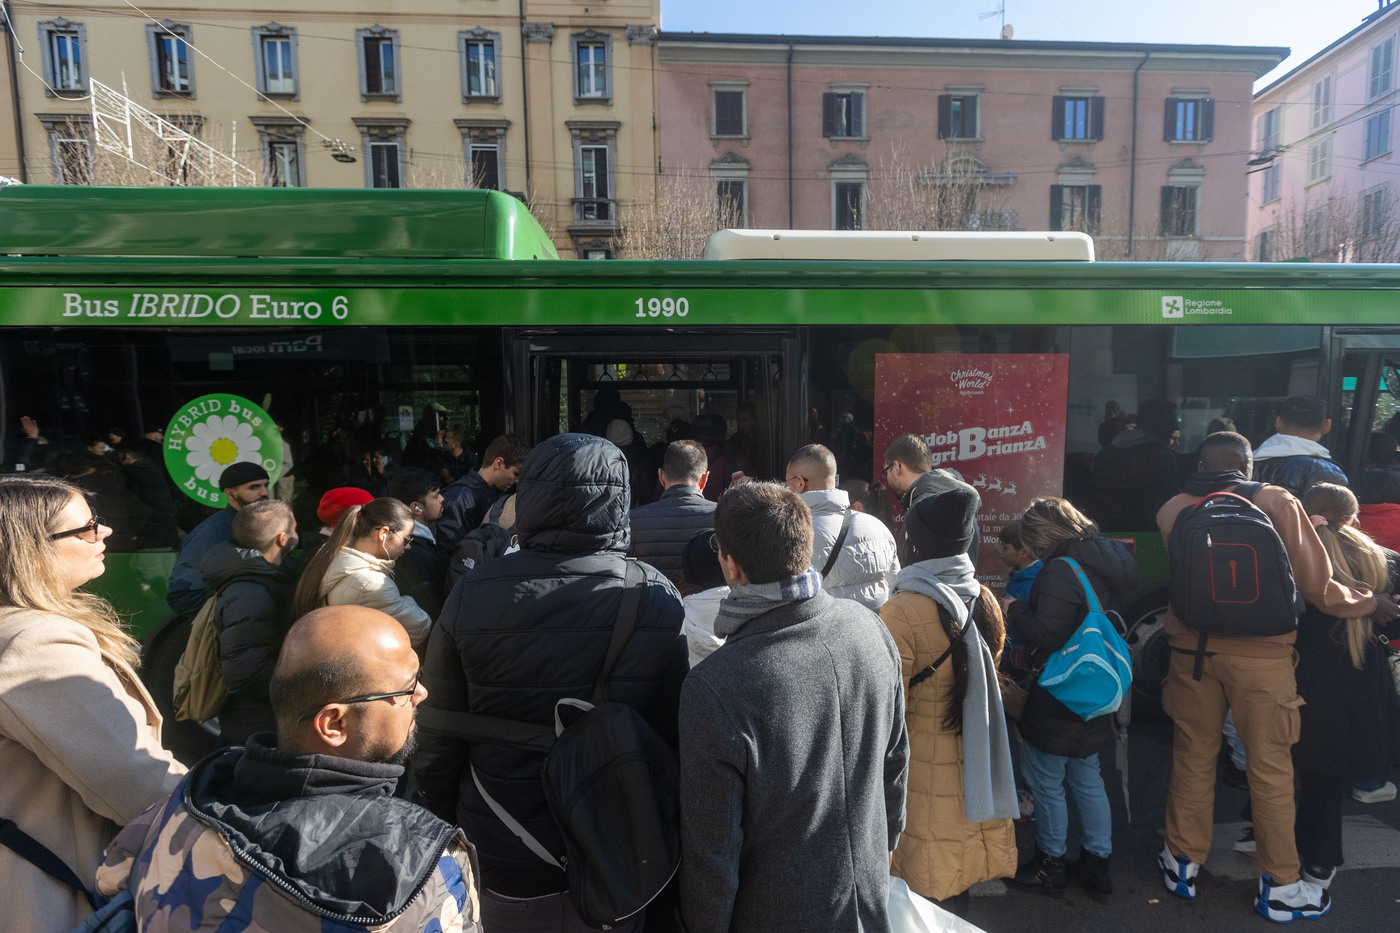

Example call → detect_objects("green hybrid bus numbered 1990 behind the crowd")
0 185 1400 756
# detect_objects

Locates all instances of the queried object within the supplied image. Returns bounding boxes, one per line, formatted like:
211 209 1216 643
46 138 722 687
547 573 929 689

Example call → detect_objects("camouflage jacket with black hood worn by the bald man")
97 737 480 933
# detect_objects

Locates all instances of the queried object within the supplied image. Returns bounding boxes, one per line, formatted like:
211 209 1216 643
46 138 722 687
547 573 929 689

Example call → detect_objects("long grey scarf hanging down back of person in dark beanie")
895 553 1021 822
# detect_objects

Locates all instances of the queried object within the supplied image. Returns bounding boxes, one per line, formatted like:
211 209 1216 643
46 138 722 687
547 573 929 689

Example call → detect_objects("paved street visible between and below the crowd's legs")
969 723 1400 933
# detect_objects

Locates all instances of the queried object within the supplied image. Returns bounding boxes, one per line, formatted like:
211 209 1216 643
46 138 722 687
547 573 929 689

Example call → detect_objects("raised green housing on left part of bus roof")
0 185 559 259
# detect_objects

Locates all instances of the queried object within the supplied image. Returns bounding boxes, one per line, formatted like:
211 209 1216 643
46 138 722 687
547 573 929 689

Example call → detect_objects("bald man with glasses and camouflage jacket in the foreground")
97 605 480 933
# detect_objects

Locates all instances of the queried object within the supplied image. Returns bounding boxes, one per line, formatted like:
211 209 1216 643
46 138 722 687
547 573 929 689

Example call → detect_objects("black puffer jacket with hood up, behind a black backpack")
413 434 689 898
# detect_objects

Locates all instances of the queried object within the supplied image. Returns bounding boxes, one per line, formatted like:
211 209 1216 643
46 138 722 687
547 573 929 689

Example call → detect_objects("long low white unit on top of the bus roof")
704 230 1093 262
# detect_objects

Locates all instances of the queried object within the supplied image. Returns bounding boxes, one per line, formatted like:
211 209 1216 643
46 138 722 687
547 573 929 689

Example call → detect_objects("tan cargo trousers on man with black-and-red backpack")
1162 651 1303 884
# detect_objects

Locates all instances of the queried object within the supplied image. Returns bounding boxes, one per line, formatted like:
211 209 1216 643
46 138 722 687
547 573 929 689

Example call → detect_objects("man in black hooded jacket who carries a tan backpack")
200 499 297 745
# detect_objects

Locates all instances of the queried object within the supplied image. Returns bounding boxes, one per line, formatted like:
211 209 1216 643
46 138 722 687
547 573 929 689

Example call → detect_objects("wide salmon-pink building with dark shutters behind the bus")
658 32 1287 259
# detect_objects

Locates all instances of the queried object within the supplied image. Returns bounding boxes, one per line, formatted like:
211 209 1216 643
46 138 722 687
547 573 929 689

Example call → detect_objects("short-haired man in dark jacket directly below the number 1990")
627 440 714 587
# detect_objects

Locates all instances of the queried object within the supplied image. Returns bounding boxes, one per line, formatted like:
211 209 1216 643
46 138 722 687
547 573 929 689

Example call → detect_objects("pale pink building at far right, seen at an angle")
1249 3 1400 262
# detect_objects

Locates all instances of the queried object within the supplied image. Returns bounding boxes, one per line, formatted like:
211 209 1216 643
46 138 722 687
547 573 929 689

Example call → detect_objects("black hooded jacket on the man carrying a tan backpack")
200 541 297 745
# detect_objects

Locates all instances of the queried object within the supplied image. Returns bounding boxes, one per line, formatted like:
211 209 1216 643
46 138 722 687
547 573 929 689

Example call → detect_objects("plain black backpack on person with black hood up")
419 560 680 930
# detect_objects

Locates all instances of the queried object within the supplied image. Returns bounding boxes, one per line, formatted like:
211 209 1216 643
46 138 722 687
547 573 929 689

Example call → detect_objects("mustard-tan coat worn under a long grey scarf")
879 590 1016 901
